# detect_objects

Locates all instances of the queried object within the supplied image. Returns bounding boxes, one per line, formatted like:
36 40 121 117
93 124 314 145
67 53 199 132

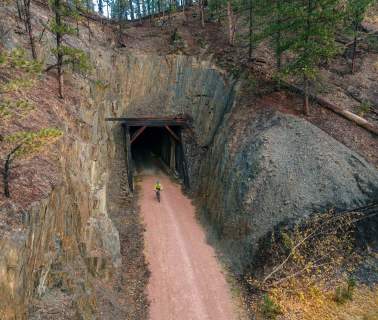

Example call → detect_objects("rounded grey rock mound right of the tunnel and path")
198 111 378 271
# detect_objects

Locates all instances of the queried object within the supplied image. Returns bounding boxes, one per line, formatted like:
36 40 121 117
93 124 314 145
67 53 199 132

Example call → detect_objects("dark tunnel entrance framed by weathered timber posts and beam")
106 117 189 191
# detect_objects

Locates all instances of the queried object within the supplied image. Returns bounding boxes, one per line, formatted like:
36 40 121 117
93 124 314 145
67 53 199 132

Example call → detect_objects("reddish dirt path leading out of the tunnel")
139 174 235 320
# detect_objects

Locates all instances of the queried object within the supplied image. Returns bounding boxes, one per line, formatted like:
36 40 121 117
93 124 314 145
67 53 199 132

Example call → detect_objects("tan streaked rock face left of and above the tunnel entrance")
0 7 233 320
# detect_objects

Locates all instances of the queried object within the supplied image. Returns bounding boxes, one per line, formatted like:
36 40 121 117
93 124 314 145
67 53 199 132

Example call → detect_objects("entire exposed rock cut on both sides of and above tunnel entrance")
0 2 378 319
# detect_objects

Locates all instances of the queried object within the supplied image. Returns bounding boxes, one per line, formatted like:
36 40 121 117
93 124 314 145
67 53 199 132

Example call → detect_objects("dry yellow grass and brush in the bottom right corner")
247 212 378 320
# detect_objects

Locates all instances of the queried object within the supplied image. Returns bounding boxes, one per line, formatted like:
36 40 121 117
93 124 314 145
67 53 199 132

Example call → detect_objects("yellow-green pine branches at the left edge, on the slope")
0 49 63 198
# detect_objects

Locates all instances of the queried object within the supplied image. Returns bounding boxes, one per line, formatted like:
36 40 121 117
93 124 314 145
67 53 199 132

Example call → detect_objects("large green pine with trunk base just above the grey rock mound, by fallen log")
279 0 342 115
